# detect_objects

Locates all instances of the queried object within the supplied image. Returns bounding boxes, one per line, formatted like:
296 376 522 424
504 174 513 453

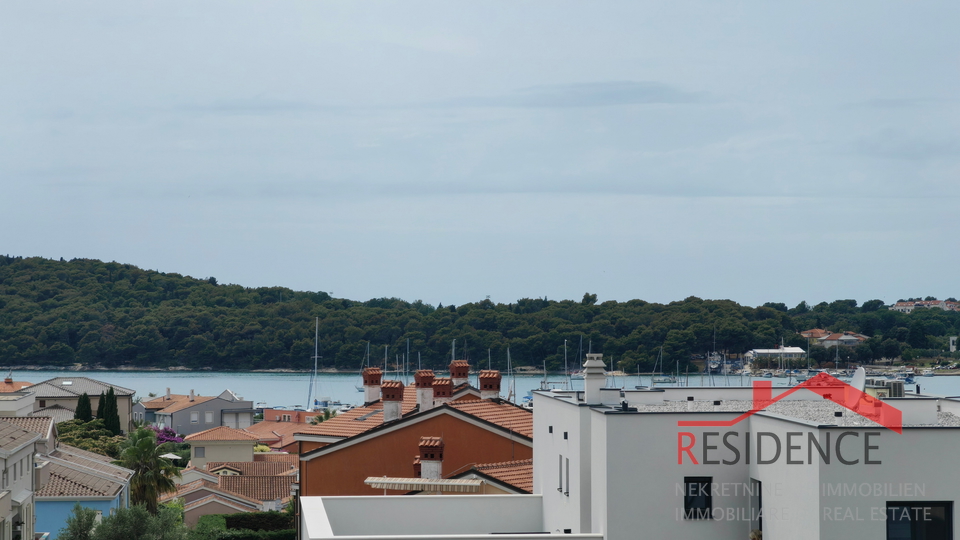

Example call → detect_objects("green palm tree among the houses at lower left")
114 428 180 514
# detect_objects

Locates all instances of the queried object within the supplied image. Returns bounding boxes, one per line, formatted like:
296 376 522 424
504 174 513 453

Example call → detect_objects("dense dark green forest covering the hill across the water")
0 256 960 371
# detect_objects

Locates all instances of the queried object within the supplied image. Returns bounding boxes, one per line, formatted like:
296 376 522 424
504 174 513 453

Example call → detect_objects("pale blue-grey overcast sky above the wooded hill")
0 0 960 306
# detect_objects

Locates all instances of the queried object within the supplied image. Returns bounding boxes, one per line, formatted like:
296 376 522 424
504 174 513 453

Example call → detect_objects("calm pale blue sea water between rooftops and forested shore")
13 371 960 407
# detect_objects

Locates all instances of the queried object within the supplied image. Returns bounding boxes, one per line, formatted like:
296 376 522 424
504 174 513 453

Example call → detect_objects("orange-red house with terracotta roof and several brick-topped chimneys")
295 364 533 495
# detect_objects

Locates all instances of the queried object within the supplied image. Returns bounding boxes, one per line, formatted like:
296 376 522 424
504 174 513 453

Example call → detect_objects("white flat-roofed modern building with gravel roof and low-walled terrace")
301 354 960 540
